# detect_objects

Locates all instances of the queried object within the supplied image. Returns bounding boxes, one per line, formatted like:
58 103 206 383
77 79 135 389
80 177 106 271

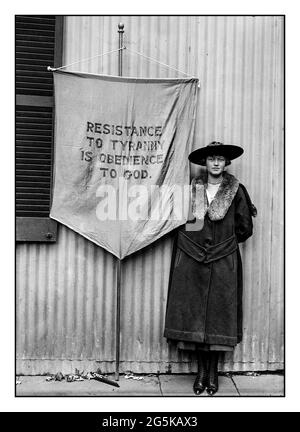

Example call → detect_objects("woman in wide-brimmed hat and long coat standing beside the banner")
164 141 256 395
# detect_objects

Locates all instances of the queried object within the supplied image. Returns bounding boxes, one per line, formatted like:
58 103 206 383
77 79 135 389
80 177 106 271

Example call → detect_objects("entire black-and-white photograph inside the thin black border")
15 13 286 404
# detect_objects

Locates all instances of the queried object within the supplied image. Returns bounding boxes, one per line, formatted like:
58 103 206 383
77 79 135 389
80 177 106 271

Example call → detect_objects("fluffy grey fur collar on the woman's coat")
192 172 239 221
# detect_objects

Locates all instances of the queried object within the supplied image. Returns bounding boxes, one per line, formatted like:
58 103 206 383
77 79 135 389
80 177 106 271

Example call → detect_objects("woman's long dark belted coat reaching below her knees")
164 174 253 346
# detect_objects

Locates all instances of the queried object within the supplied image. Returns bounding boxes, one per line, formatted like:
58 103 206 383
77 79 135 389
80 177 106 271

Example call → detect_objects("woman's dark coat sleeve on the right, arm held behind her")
235 186 253 243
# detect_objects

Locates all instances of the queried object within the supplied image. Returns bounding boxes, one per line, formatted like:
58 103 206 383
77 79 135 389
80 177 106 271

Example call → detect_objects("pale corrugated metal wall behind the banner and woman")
16 16 284 373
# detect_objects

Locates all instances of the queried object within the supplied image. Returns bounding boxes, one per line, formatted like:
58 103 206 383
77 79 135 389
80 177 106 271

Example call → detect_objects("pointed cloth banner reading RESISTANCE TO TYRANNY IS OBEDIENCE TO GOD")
50 71 198 259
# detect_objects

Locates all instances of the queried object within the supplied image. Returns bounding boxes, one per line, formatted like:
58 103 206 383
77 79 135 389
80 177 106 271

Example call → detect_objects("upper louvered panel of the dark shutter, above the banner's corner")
16 15 55 96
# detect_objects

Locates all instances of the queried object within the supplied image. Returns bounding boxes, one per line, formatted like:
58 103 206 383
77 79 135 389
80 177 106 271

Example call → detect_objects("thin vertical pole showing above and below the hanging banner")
115 23 124 381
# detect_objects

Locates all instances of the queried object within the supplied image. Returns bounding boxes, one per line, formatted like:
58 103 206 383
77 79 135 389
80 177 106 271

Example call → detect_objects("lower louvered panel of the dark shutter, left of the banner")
16 106 52 216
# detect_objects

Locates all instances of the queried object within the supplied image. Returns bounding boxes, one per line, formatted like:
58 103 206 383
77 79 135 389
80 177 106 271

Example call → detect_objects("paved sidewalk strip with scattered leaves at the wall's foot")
16 374 284 397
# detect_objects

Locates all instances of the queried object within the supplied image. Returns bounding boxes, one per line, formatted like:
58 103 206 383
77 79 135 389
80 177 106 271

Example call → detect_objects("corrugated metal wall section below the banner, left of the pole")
16 225 115 373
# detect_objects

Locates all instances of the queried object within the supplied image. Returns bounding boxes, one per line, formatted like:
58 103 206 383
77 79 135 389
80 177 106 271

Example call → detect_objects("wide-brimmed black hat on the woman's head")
189 141 244 165
